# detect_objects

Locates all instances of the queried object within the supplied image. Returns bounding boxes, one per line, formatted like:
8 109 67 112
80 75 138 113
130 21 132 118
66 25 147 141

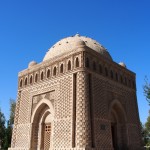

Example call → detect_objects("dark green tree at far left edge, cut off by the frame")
0 109 6 149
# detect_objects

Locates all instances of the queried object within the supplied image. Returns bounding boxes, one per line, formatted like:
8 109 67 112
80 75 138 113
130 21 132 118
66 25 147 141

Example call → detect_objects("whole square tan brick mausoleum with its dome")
9 34 142 150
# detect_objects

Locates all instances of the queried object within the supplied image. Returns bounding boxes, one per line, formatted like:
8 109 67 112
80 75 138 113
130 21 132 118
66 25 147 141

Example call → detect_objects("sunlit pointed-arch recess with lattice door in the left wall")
31 99 54 150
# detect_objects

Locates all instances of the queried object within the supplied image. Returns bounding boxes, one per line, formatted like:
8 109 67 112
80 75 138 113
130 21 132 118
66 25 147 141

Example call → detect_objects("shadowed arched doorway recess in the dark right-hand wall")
109 100 128 150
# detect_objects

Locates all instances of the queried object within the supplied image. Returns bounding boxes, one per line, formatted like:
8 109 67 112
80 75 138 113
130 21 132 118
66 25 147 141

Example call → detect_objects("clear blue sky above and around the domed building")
0 0 150 122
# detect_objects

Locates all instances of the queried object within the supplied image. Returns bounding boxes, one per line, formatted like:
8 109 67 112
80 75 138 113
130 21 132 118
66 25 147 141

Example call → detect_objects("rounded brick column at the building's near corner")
76 71 91 148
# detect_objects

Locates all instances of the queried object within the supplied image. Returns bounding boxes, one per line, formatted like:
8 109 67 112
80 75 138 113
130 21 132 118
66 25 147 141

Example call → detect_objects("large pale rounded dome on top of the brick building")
43 34 112 61
